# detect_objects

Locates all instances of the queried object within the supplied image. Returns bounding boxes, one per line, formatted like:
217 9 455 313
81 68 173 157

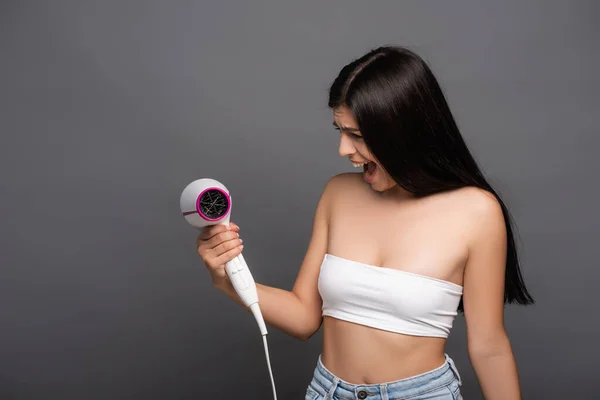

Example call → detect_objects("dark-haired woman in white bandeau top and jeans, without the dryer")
198 47 533 400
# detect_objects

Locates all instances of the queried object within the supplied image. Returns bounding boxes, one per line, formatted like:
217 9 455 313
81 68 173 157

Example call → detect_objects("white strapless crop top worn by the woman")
318 254 463 338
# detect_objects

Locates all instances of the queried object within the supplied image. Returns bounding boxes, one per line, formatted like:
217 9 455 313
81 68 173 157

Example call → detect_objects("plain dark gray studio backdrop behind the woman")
0 1 600 399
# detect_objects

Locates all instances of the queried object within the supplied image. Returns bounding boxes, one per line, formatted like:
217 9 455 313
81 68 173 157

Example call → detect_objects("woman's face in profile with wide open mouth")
333 106 397 192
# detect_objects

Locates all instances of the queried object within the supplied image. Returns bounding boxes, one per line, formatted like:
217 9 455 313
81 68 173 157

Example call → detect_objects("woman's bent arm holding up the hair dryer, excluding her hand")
218 177 335 340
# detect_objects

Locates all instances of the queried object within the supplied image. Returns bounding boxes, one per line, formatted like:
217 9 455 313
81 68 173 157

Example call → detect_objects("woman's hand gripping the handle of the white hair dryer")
196 222 244 290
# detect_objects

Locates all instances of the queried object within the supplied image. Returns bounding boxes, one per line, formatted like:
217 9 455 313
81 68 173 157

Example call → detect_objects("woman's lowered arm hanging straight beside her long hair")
463 192 521 400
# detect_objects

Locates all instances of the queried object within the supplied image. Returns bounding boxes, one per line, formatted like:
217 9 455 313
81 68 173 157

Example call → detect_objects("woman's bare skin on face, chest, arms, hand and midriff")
198 107 520 400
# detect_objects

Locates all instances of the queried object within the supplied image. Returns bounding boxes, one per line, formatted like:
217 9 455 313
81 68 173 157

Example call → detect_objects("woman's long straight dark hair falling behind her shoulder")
329 46 534 311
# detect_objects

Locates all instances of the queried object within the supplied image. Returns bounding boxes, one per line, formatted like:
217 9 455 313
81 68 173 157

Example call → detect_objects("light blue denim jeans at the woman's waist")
304 354 462 400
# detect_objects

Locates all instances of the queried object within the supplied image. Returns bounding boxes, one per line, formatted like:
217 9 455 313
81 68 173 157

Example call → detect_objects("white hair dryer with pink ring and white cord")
179 178 277 400
